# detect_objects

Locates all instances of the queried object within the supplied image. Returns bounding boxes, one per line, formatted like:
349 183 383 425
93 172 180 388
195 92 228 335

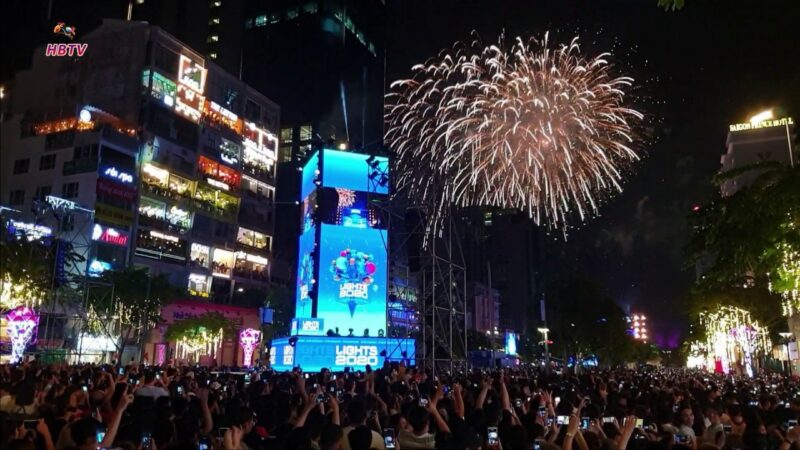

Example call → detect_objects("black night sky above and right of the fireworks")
387 0 800 346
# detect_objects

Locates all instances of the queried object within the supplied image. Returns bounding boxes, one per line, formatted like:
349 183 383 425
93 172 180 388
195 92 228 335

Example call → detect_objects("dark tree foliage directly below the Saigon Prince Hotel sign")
686 162 800 298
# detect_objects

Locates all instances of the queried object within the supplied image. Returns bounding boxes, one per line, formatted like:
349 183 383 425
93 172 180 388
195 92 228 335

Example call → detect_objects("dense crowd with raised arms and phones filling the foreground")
0 363 800 450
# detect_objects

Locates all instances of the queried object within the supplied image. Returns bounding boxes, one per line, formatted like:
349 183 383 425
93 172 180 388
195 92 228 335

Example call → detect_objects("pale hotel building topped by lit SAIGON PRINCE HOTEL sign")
720 110 798 197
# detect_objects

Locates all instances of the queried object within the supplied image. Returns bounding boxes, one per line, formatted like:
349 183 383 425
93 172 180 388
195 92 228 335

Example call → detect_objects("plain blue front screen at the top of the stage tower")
322 149 389 198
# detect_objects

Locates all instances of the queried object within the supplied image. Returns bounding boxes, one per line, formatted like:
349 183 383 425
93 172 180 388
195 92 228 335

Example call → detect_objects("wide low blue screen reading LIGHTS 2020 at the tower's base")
270 336 416 372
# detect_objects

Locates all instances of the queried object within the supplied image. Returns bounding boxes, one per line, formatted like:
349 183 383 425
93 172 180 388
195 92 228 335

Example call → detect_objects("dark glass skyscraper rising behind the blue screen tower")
241 0 385 280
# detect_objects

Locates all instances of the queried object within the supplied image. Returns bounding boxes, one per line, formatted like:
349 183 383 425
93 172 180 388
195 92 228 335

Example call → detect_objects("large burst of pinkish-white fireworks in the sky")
386 34 643 234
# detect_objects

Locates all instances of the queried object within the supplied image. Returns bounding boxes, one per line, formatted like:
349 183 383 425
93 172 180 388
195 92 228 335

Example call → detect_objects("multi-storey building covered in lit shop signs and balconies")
0 20 279 306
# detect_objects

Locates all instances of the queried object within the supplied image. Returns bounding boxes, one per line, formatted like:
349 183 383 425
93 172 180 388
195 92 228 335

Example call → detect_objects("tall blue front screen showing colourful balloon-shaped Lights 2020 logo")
317 224 387 337
